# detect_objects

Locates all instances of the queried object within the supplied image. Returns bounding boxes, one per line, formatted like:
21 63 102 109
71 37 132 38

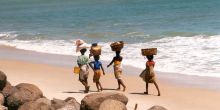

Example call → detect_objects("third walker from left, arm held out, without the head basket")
107 51 126 91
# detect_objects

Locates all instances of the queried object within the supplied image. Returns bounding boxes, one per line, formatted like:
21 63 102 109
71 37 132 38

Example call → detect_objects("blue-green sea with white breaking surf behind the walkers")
0 0 220 77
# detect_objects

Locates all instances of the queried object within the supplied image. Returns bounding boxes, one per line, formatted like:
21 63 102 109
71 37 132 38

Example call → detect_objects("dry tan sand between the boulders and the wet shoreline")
0 47 220 110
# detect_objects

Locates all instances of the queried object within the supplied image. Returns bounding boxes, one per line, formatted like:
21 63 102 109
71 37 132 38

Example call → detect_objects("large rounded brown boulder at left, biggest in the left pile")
6 83 43 110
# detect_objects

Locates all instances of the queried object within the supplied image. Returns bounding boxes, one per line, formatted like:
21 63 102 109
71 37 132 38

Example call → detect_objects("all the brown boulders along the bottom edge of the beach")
0 71 166 110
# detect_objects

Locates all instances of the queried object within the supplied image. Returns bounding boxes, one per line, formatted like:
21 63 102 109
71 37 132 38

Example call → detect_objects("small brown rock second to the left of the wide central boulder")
51 98 65 110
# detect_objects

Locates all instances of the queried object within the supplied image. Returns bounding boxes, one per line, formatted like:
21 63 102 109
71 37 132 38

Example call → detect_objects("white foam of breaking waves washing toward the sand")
0 35 220 77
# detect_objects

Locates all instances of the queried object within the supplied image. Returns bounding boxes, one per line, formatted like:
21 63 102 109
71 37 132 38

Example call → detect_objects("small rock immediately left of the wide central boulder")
58 97 80 110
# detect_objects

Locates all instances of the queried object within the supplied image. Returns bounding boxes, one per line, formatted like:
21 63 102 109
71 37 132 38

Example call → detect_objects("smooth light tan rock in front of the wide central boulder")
99 99 127 110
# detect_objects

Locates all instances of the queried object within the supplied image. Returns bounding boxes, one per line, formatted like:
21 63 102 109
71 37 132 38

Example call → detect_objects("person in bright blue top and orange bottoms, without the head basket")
89 55 105 92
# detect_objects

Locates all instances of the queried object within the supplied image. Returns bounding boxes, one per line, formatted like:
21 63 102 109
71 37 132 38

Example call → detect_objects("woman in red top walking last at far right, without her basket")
140 55 160 96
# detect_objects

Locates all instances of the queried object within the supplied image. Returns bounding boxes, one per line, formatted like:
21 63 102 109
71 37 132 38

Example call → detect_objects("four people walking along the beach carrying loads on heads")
76 40 160 96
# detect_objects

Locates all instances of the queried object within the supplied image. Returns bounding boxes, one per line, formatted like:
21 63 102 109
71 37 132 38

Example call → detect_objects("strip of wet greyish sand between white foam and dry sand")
0 45 220 91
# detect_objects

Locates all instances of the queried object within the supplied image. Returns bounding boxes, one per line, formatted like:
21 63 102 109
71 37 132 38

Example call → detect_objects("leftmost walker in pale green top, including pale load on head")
76 40 90 93
